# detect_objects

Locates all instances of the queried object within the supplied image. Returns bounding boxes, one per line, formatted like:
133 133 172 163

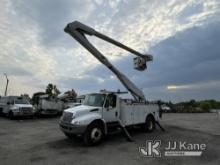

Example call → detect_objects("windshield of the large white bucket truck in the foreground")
83 94 105 107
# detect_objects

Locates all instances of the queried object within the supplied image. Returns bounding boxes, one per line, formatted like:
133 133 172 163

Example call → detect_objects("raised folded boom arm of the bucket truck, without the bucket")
64 21 153 101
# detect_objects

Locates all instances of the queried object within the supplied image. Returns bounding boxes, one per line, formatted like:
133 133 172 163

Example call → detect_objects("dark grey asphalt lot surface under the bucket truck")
0 113 220 165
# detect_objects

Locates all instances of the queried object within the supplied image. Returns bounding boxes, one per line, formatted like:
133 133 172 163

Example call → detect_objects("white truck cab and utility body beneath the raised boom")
59 93 159 145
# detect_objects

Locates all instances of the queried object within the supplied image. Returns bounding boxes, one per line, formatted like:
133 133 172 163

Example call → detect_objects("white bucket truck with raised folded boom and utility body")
59 21 162 145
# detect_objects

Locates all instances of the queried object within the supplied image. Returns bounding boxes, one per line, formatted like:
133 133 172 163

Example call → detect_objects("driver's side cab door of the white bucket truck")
102 94 119 122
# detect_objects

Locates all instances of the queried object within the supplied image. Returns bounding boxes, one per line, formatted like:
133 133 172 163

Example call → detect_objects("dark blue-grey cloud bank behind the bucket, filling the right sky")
82 22 220 100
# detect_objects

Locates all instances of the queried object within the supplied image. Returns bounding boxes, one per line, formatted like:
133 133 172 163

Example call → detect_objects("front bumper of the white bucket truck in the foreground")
59 121 86 135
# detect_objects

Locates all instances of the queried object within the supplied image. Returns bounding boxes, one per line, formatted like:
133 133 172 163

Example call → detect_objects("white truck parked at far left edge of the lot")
0 96 35 119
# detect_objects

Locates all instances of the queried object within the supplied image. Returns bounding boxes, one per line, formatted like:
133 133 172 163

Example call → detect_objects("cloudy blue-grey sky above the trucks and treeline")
0 0 220 101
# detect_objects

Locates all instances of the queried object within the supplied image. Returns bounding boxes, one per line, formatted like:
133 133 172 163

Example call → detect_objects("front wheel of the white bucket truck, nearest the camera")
84 122 104 146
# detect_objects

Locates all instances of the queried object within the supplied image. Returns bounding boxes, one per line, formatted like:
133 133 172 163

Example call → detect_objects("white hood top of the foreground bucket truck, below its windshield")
65 105 101 114
